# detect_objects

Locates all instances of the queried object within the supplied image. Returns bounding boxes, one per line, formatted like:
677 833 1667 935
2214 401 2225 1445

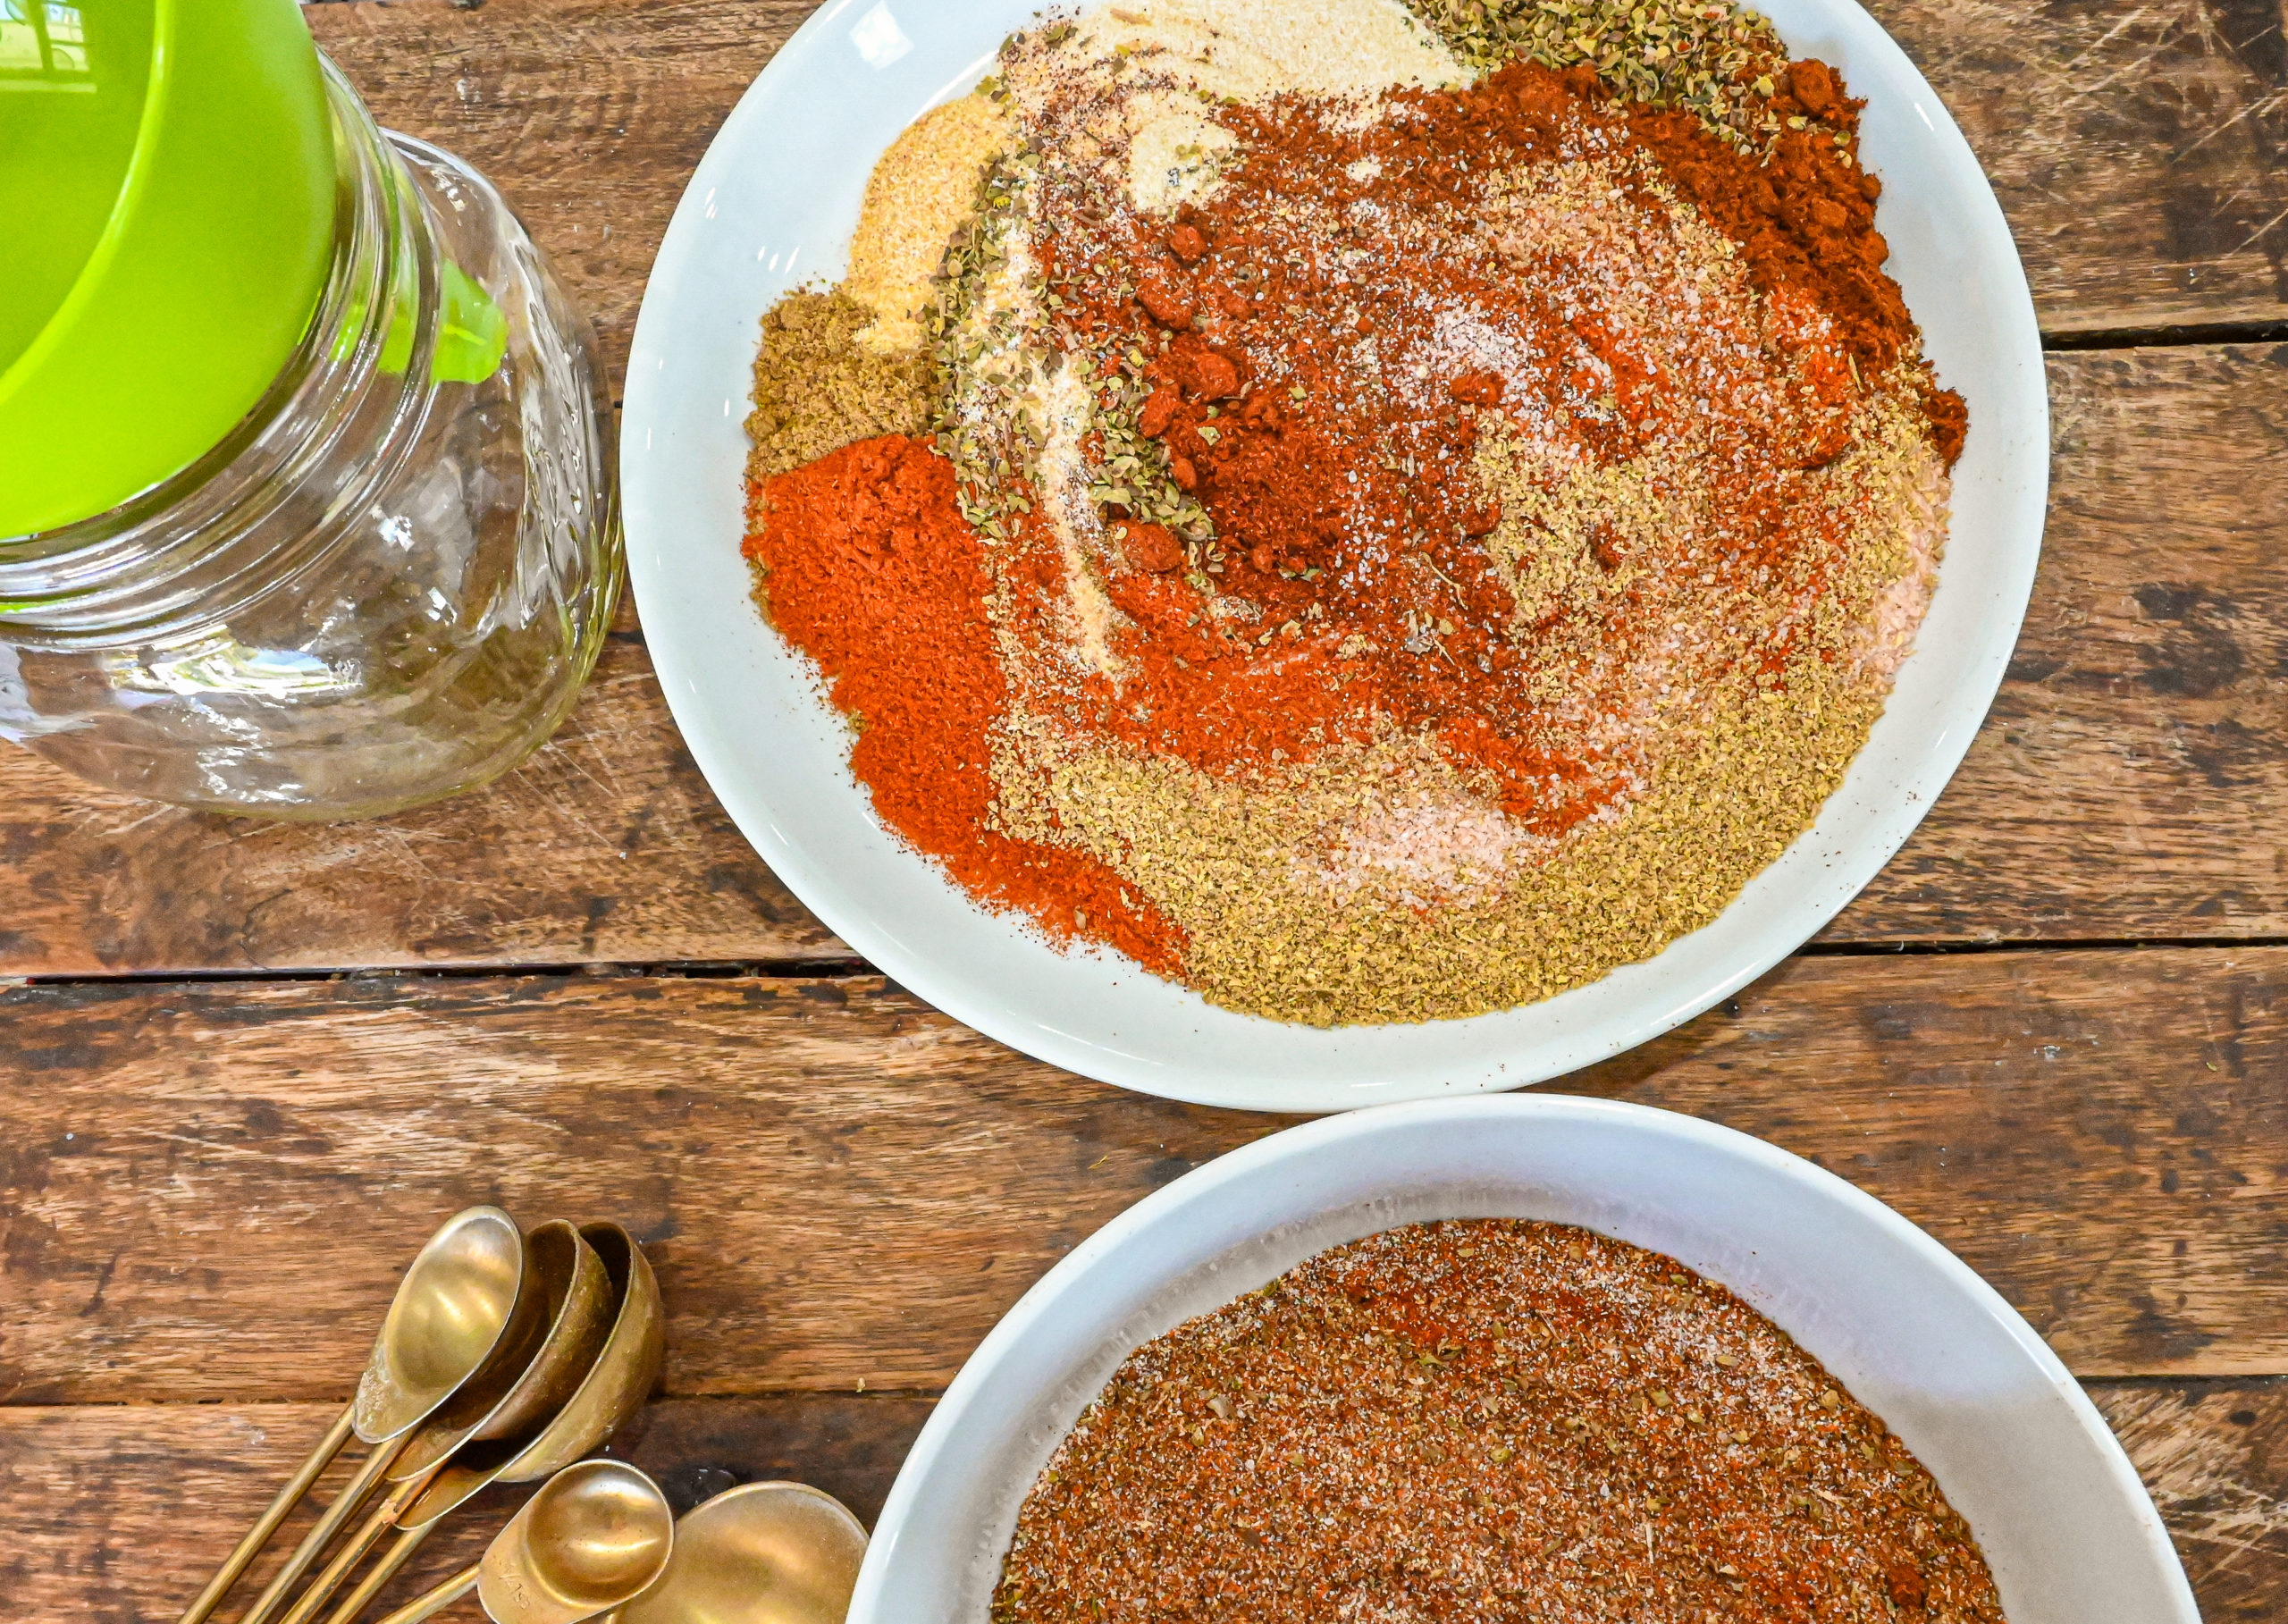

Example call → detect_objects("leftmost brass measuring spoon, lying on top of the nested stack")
181 1206 526 1624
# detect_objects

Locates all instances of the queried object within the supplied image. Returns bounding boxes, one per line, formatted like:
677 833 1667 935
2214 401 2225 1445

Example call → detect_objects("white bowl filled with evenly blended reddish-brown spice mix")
851 1093 2199 1624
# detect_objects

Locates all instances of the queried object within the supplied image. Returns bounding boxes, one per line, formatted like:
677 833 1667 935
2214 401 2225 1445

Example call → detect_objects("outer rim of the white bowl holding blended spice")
849 1093 2201 1624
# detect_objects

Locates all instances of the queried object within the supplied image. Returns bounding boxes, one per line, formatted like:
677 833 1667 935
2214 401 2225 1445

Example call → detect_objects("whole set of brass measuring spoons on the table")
181 1207 865 1624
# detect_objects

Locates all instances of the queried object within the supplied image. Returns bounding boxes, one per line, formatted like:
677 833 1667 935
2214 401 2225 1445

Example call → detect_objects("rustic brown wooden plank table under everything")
0 0 2288 1620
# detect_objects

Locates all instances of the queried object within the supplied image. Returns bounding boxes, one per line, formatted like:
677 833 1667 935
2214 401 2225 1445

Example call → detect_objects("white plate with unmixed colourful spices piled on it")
625 0 2048 1109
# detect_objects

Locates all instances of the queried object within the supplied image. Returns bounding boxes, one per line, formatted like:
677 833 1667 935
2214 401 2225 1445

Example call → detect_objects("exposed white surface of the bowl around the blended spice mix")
849 1093 2201 1624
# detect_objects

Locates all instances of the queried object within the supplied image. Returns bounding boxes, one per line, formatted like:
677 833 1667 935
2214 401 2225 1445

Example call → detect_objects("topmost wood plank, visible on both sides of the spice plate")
311 0 2288 366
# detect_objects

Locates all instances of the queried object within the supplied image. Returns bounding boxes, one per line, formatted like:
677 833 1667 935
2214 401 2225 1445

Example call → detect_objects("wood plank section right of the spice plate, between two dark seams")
1826 345 2288 942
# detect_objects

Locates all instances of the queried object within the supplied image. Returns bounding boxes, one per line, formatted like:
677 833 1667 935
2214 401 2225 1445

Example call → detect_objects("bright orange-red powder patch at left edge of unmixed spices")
744 434 1183 974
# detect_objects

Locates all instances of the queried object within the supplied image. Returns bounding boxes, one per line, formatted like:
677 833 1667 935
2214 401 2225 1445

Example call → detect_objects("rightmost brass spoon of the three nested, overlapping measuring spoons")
327 1224 666 1624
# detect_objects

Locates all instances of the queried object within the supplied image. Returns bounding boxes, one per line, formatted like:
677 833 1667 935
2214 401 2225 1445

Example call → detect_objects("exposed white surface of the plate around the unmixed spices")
622 0 2050 1112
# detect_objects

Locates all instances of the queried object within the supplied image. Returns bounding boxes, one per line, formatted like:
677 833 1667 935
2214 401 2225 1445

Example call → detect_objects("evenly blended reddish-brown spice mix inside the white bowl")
993 1219 2002 1624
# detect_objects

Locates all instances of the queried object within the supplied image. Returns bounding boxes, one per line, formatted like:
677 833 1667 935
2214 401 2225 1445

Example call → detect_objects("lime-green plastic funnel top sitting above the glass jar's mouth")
0 0 334 537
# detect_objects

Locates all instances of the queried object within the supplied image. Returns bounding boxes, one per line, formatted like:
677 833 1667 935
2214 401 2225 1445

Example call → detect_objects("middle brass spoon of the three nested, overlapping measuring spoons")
279 1219 611 1624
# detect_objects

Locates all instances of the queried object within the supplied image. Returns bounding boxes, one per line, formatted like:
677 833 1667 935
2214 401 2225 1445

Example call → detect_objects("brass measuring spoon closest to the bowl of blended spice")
609 1482 865 1624
